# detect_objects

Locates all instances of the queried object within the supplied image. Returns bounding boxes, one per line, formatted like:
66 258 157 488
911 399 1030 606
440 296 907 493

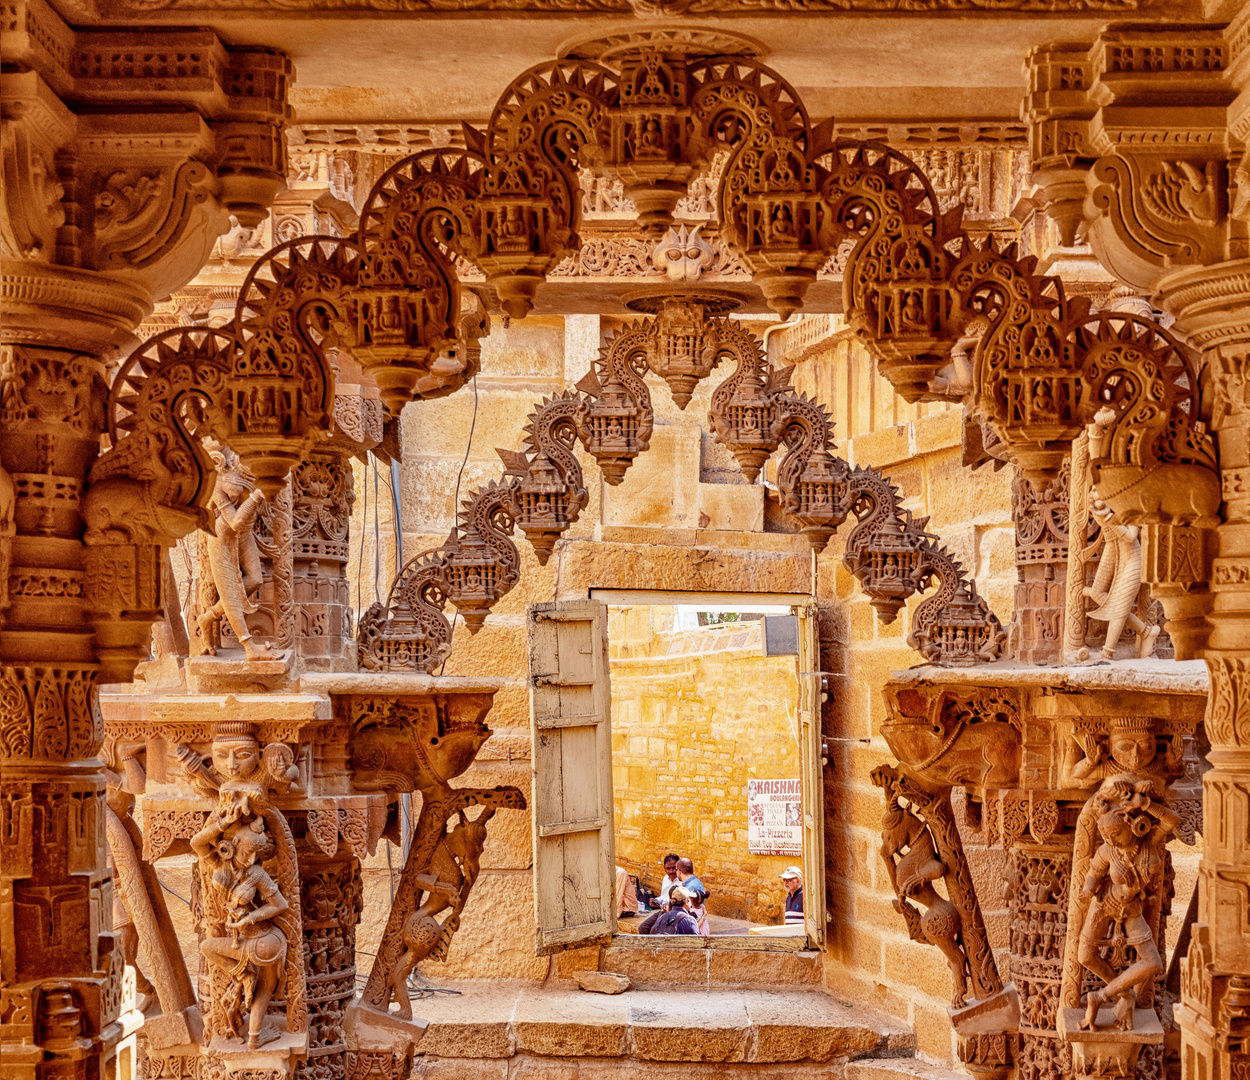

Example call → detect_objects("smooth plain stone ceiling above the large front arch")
75 0 1236 124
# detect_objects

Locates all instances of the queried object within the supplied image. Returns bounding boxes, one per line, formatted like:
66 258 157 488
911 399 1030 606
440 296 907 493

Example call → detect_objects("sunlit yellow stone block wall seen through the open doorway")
609 606 801 923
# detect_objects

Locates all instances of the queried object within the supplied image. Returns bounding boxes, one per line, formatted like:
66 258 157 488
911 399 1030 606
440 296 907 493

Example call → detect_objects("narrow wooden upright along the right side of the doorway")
793 606 825 948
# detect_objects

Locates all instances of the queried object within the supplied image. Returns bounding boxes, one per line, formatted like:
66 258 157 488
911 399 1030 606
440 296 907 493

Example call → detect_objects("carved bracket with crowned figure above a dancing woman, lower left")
178 721 308 1050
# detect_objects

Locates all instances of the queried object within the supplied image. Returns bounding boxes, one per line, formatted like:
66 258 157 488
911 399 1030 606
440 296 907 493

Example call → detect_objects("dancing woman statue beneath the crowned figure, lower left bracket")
191 814 290 1050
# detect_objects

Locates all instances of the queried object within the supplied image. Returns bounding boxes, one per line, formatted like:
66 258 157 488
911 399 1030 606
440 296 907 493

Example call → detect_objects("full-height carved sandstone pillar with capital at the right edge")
1029 11 1250 1080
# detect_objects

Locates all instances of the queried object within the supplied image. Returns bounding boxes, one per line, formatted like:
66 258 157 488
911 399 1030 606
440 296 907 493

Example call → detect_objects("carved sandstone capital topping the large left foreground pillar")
0 0 293 355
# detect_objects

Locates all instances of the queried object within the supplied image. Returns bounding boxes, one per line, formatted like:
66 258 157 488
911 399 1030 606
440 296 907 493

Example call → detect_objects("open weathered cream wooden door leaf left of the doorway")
525 600 616 956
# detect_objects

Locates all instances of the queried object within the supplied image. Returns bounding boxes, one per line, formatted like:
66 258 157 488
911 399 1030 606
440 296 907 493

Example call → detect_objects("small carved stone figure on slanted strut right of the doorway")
881 799 968 1009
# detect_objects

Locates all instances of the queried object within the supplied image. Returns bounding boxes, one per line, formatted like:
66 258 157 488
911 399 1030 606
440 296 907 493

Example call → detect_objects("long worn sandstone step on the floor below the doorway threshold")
413 983 910 1065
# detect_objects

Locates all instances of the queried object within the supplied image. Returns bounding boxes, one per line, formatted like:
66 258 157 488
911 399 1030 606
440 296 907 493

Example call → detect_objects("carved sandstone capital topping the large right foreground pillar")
1025 25 1246 306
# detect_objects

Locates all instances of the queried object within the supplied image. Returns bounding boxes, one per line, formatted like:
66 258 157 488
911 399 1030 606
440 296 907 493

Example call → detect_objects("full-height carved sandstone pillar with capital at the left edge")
0 3 289 1080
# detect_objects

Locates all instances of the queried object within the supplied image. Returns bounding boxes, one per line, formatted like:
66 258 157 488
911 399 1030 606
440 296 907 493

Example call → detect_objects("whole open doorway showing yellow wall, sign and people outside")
593 590 824 948
